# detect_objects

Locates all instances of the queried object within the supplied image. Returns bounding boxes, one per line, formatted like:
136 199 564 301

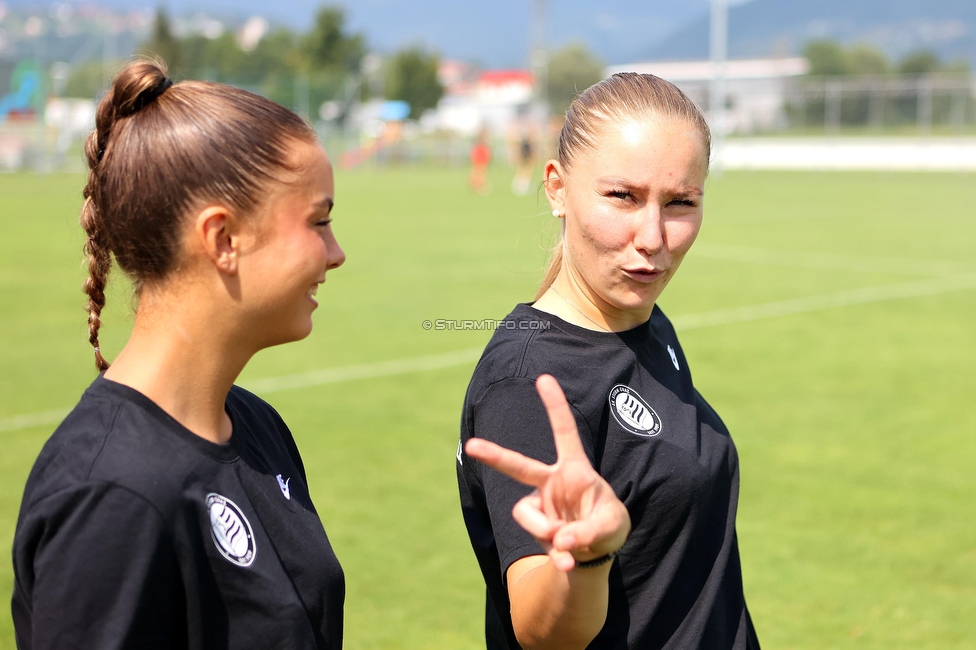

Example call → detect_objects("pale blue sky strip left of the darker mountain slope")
0 0 708 67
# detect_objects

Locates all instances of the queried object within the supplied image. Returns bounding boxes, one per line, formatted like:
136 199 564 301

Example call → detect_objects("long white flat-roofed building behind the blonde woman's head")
606 58 810 133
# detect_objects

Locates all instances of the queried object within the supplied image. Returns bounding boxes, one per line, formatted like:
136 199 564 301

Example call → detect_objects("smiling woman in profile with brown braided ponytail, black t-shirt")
13 61 345 649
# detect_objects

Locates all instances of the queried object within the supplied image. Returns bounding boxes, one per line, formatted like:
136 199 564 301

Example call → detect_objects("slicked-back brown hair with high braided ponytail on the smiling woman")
80 59 316 371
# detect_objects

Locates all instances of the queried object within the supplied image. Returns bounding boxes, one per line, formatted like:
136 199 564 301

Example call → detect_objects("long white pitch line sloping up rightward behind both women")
0 274 976 432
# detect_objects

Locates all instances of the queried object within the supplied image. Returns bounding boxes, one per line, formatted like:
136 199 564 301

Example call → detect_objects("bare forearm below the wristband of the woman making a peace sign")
509 556 613 650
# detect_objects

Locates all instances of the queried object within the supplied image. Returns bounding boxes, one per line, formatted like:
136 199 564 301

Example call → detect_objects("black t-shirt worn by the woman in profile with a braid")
13 377 345 650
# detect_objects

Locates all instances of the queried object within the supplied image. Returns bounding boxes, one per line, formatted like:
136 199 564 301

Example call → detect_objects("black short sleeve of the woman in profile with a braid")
13 484 186 650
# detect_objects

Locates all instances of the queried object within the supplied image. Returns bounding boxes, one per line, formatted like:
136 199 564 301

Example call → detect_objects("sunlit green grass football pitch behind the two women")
0 168 976 650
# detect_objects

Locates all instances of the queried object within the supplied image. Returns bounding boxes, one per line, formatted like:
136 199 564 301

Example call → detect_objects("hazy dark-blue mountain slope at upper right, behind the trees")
634 0 976 67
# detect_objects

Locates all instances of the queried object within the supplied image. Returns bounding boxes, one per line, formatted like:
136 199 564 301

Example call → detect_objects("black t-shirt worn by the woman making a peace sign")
457 305 759 650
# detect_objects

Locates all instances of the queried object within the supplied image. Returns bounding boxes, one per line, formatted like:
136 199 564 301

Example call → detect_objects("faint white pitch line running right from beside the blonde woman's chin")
691 242 976 276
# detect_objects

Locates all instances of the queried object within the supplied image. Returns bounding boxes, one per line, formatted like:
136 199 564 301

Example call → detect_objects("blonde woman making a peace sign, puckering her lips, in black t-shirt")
457 73 759 650
